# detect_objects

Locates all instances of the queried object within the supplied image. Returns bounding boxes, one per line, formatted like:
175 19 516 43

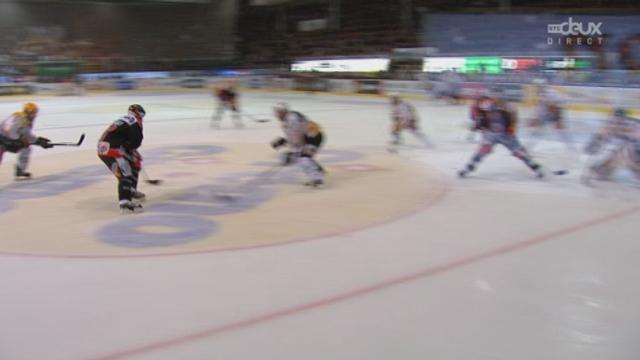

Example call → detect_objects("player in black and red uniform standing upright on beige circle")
98 104 146 212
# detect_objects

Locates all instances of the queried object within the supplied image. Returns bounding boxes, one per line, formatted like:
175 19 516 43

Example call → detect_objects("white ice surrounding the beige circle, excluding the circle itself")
0 92 640 360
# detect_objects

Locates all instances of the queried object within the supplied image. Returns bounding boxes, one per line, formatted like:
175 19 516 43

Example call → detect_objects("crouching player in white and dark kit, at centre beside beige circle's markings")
271 103 324 187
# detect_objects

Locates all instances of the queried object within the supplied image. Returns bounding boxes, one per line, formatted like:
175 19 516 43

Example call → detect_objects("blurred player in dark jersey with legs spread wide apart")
458 99 544 178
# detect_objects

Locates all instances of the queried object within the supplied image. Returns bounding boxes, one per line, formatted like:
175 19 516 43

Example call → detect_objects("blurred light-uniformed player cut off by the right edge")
583 108 640 183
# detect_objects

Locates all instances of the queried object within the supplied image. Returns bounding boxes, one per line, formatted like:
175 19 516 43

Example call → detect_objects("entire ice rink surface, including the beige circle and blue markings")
0 92 640 360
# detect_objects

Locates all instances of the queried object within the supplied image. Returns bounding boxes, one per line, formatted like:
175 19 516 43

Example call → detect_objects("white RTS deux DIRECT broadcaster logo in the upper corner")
547 17 604 45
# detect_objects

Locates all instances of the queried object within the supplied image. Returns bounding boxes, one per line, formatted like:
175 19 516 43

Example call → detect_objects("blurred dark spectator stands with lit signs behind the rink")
0 0 640 88
